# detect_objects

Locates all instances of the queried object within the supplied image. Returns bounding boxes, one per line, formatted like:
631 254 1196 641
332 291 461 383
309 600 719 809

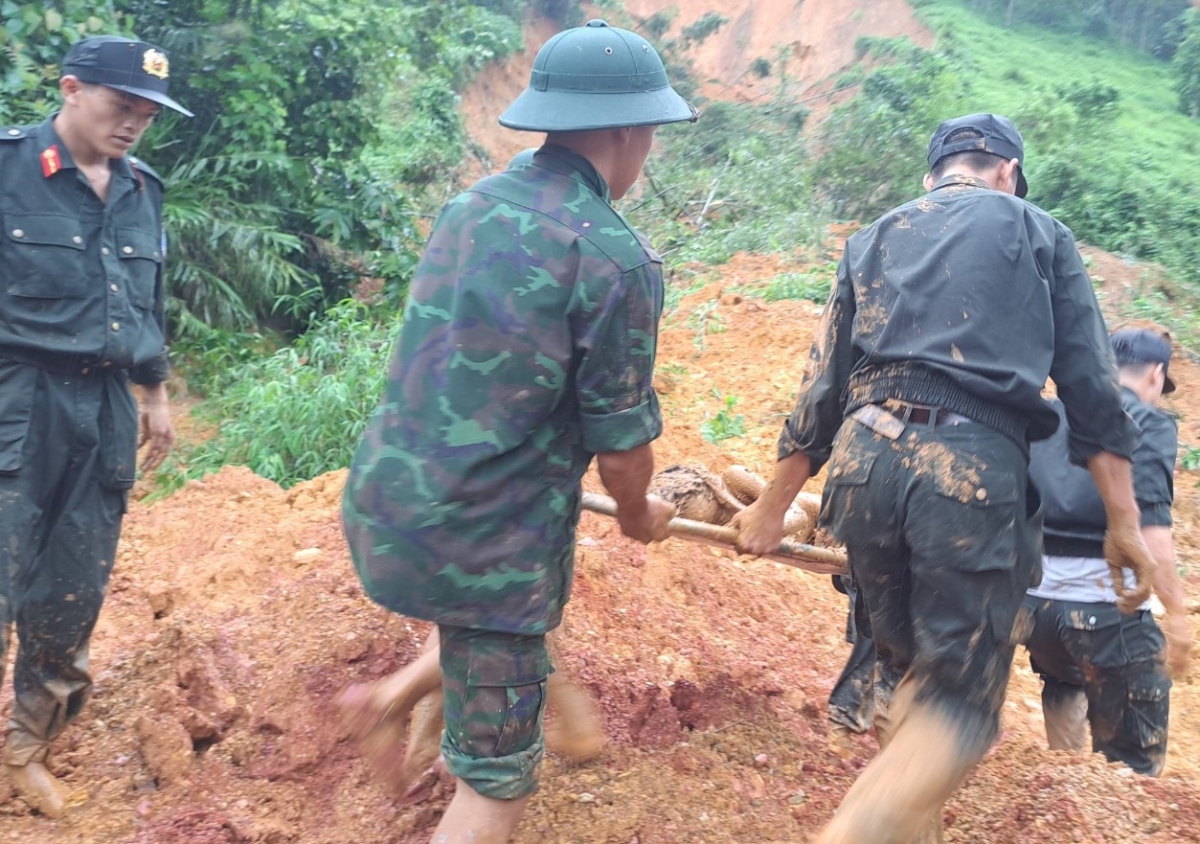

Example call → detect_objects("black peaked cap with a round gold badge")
62 35 194 118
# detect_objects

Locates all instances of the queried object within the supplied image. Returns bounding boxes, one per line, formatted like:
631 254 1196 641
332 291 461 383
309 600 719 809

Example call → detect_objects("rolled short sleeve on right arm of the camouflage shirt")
574 262 662 454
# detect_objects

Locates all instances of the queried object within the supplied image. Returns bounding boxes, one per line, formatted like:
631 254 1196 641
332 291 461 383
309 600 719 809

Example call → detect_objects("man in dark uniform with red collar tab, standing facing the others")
0 36 188 816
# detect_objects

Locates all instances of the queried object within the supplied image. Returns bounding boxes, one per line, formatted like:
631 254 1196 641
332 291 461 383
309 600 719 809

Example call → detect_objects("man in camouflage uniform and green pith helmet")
342 20 695 844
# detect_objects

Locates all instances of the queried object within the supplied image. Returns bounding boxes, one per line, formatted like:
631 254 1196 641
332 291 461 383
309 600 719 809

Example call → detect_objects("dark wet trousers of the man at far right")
1024 595 1171 777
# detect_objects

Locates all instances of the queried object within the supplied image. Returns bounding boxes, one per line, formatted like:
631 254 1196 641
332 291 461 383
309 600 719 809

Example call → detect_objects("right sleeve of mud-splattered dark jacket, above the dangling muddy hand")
1050 226 1138 466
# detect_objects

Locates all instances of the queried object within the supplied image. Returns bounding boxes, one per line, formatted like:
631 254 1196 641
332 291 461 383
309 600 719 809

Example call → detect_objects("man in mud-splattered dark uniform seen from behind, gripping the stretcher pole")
733 114 1153 844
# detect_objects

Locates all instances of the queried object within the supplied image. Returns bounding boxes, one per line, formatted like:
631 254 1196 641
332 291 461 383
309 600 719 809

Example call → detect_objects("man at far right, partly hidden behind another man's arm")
1025 329 1192 777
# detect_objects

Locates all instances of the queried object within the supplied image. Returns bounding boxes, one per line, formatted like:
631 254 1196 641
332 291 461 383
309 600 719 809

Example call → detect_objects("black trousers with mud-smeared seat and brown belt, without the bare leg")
822 418 1042 759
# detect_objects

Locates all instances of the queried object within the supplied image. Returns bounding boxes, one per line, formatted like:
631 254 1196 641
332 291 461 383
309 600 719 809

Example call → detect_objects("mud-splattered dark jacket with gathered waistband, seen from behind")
779 176 1136 472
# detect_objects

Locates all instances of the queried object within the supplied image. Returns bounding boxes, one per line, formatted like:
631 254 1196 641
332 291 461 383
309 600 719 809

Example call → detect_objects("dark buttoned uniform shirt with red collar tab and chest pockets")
0 116 170 384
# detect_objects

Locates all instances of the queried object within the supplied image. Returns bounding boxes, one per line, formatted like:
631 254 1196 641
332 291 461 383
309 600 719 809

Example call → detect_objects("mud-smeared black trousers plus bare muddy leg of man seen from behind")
815 419 1040 844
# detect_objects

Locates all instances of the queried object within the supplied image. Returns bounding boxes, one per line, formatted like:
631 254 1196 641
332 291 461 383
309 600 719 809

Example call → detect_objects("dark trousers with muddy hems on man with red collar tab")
0 360 137 765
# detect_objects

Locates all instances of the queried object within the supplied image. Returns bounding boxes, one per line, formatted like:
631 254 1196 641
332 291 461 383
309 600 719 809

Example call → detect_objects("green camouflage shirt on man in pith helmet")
343 146 662 634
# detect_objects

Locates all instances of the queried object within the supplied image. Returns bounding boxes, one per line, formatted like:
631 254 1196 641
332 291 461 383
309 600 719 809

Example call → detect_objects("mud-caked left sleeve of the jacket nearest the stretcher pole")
778 247 854 474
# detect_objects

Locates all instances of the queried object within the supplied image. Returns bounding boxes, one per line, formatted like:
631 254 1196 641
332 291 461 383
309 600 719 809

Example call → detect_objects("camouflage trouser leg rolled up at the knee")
438 624 553 800
